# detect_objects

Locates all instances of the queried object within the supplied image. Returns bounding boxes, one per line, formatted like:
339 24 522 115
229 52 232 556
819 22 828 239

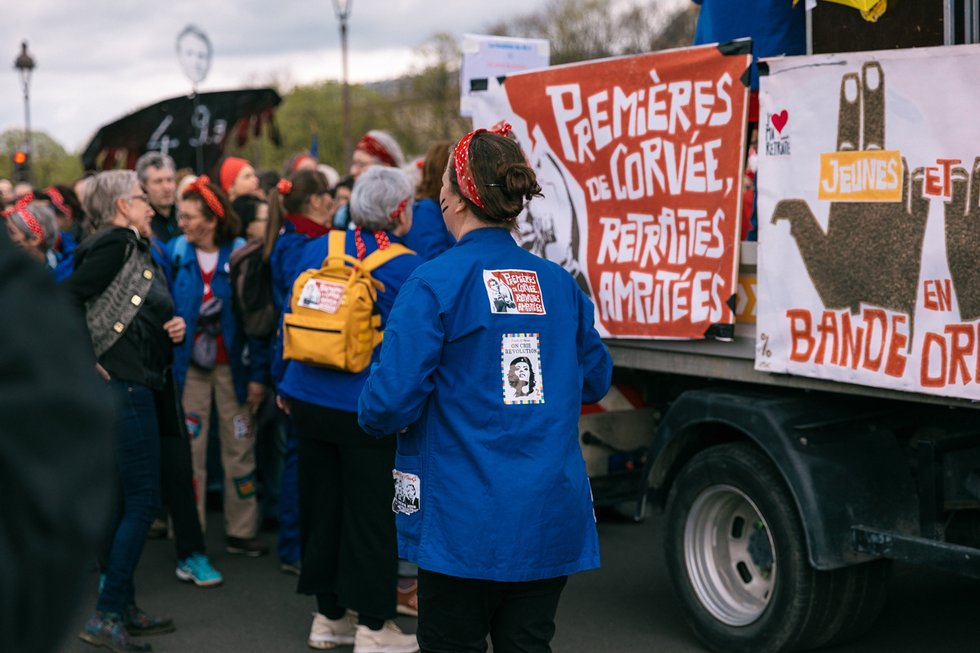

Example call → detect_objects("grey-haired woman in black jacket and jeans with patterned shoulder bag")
64 170 185 651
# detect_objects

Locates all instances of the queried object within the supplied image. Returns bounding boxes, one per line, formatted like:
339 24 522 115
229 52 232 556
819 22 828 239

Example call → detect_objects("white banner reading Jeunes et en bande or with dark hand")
756 46 980 399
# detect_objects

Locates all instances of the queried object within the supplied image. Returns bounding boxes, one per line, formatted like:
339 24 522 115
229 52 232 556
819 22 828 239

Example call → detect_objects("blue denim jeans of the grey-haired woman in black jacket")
96 380 160 614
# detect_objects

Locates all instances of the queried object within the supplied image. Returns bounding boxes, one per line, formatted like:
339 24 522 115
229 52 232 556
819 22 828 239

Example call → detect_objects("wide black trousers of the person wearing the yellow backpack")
292 400 398 625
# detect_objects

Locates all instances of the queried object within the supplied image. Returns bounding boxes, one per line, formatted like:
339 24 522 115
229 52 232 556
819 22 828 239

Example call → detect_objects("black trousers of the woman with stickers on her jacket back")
418 569 568 653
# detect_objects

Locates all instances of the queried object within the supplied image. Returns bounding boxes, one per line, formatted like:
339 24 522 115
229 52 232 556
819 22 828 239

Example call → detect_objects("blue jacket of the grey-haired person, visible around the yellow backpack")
277 231 422 413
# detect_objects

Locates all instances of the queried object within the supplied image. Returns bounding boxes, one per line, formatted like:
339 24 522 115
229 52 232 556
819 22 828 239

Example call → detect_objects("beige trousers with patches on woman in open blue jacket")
183 365 259 538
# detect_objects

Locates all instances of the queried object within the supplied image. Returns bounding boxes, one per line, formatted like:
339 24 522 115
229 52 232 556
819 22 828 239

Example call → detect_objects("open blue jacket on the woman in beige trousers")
168 236 255 403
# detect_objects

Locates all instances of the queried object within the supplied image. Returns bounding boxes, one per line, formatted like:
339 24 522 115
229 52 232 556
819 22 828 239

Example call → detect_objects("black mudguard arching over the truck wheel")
643 388 919 570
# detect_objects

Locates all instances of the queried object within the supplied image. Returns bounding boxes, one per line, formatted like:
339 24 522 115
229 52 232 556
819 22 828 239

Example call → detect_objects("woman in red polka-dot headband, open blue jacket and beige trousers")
171 175 267 557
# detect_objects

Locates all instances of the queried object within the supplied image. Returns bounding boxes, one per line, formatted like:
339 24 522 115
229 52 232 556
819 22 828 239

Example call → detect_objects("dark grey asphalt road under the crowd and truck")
61 514 980 653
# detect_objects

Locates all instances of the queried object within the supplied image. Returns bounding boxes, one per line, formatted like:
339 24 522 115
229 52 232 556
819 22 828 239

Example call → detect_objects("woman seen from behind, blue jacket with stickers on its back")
359 125 612 651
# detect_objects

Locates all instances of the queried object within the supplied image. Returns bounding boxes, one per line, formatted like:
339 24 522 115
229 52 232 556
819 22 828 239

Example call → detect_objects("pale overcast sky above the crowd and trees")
0 0 580 151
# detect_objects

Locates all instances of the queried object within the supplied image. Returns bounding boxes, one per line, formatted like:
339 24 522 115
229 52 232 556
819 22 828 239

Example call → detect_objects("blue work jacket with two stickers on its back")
358 228 612 582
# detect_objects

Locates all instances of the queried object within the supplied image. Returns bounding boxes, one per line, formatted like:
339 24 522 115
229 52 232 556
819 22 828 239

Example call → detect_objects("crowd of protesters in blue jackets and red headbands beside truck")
0 125 611 653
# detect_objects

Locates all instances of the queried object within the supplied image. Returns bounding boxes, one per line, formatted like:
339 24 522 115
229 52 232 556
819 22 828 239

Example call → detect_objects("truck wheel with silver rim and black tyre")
664 443 844 653
